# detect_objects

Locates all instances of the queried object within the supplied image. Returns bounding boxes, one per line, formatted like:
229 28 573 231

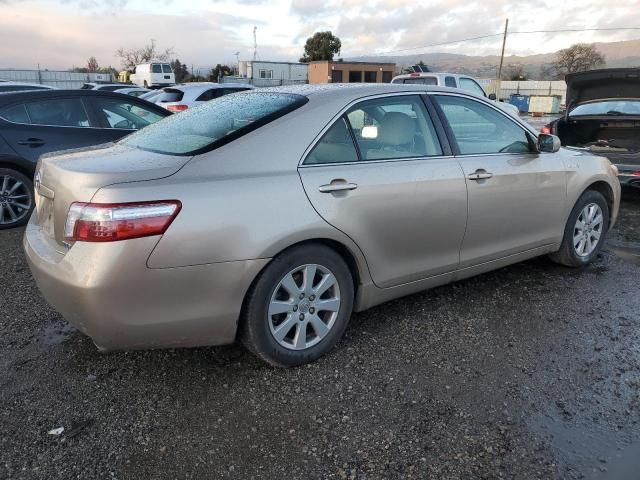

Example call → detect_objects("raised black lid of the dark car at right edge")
566 68 640 113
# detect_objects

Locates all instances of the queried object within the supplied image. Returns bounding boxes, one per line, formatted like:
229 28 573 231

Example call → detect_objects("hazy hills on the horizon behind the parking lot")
345 39 640 80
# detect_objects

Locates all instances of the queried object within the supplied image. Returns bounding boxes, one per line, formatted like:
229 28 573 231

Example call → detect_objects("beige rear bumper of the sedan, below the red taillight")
23 220 268 350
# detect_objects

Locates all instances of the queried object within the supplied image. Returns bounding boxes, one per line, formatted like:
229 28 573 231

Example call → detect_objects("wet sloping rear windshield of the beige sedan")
120 92 307 155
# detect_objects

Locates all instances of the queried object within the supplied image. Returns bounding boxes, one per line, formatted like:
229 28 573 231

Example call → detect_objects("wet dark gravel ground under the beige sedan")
0 192 640 479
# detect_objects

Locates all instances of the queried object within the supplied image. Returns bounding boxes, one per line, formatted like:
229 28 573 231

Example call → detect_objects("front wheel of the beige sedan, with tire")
550 190 609 267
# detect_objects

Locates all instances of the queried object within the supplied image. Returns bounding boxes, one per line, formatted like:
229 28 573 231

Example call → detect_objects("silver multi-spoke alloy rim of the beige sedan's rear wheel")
267 264 340 350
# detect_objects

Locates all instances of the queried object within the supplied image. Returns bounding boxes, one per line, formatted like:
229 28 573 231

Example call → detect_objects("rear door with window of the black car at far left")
0 97 110 162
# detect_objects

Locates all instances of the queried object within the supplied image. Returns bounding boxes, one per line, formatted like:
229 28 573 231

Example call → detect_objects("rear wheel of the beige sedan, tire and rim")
240 245 354 367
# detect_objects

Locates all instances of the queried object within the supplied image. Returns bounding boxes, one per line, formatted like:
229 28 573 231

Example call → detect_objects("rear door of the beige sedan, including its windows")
299 94 467 287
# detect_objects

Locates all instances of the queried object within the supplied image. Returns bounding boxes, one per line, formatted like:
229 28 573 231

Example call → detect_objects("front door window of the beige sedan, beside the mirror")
433 95 534 155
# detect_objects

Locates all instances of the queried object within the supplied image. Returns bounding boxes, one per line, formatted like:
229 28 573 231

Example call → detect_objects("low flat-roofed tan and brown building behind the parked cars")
309 60 396 83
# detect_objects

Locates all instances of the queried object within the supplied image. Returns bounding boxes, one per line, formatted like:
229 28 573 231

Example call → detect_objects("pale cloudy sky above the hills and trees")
0 0 640 69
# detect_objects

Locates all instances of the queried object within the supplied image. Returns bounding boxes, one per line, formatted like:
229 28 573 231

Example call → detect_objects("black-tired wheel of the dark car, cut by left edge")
0 168 35 230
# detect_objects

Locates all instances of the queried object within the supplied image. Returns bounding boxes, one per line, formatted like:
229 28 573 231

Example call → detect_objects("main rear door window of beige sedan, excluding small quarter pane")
347 95 442 160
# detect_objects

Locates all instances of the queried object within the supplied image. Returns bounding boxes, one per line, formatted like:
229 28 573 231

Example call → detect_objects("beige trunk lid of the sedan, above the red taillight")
34 144 191 245
